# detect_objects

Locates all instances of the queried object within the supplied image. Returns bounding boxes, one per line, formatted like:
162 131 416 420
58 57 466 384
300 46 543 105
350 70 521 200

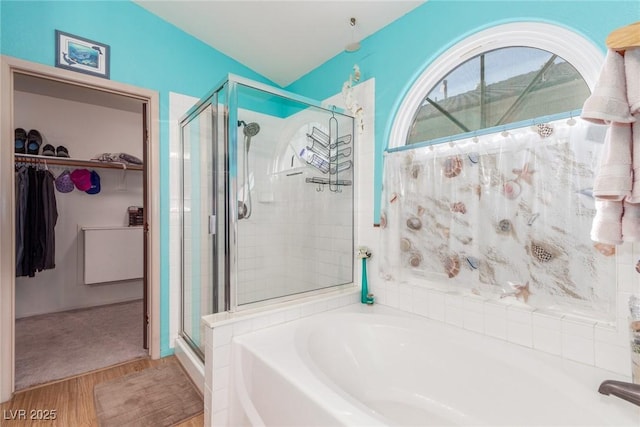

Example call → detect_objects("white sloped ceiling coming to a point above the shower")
135 0 425 86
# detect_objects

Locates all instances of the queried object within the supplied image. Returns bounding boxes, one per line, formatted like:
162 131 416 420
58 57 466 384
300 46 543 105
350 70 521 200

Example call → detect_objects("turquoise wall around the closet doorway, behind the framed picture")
0 0 273 356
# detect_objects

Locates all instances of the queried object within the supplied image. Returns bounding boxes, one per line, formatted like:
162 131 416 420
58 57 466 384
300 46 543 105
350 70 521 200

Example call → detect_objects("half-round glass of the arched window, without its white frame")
407 47 590 144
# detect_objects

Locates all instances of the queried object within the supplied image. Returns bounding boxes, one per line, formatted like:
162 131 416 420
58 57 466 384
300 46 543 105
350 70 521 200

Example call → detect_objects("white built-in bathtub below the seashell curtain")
229 305 640 427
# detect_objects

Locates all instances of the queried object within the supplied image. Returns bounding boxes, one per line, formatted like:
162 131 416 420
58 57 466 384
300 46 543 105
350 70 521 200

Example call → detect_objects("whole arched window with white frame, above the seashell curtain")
389 23 603 148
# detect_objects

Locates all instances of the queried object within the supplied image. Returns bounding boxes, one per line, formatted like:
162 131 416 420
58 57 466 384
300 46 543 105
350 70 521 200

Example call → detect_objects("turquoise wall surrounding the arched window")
287 0 640 223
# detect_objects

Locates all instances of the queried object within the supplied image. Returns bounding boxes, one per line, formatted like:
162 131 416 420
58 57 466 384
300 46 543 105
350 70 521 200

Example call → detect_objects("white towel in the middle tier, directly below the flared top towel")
593 123 640 200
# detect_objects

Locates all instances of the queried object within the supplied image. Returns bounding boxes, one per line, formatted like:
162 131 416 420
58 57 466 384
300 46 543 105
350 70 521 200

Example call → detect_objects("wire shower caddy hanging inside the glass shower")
305 116 353 192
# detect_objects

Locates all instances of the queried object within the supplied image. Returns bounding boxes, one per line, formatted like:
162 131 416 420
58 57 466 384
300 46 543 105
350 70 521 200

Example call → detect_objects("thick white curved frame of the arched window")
387 22 604 149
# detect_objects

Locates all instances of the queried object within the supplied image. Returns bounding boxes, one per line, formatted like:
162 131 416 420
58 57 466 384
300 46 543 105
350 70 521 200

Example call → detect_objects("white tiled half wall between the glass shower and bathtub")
203 290 359 426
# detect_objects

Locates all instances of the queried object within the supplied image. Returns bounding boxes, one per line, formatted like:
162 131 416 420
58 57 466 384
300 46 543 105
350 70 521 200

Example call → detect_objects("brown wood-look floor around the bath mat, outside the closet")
0 356 204 427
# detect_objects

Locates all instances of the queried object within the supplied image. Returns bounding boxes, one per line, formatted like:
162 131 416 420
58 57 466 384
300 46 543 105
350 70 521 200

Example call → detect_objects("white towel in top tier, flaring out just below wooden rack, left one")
580 49 635 124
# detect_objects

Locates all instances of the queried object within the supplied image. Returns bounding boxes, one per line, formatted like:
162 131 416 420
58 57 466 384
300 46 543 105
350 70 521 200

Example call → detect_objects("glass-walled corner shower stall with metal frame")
180 75 355 359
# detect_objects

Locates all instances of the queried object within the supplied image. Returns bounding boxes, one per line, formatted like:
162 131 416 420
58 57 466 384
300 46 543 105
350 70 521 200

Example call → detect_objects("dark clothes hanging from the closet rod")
16 166 58 277
